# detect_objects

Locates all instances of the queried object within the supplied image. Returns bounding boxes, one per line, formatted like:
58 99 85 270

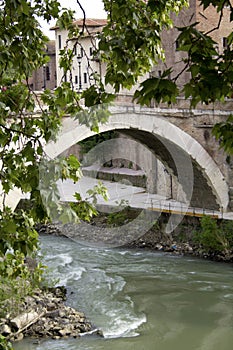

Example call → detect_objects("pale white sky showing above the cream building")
40 0 106 39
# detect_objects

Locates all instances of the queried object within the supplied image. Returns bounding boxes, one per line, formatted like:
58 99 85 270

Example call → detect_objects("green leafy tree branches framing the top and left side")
0 0 233 342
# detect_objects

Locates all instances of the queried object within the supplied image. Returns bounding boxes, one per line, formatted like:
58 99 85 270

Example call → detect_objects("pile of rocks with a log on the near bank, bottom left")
0 287 102 342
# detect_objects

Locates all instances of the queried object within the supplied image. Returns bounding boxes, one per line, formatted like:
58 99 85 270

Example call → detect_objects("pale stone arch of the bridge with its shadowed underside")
45 106 229 211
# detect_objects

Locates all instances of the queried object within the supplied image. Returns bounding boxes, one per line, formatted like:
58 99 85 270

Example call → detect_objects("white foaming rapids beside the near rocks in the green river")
38 239 146 338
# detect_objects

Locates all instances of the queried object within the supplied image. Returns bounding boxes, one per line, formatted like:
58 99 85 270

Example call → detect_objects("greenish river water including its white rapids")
14 236 233 350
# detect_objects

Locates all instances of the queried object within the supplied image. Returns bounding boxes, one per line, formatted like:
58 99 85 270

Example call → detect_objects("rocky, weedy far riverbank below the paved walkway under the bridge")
35 208 233 263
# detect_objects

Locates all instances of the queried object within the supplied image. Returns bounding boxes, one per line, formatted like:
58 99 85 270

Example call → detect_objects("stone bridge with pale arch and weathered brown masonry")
46 96 233 212
